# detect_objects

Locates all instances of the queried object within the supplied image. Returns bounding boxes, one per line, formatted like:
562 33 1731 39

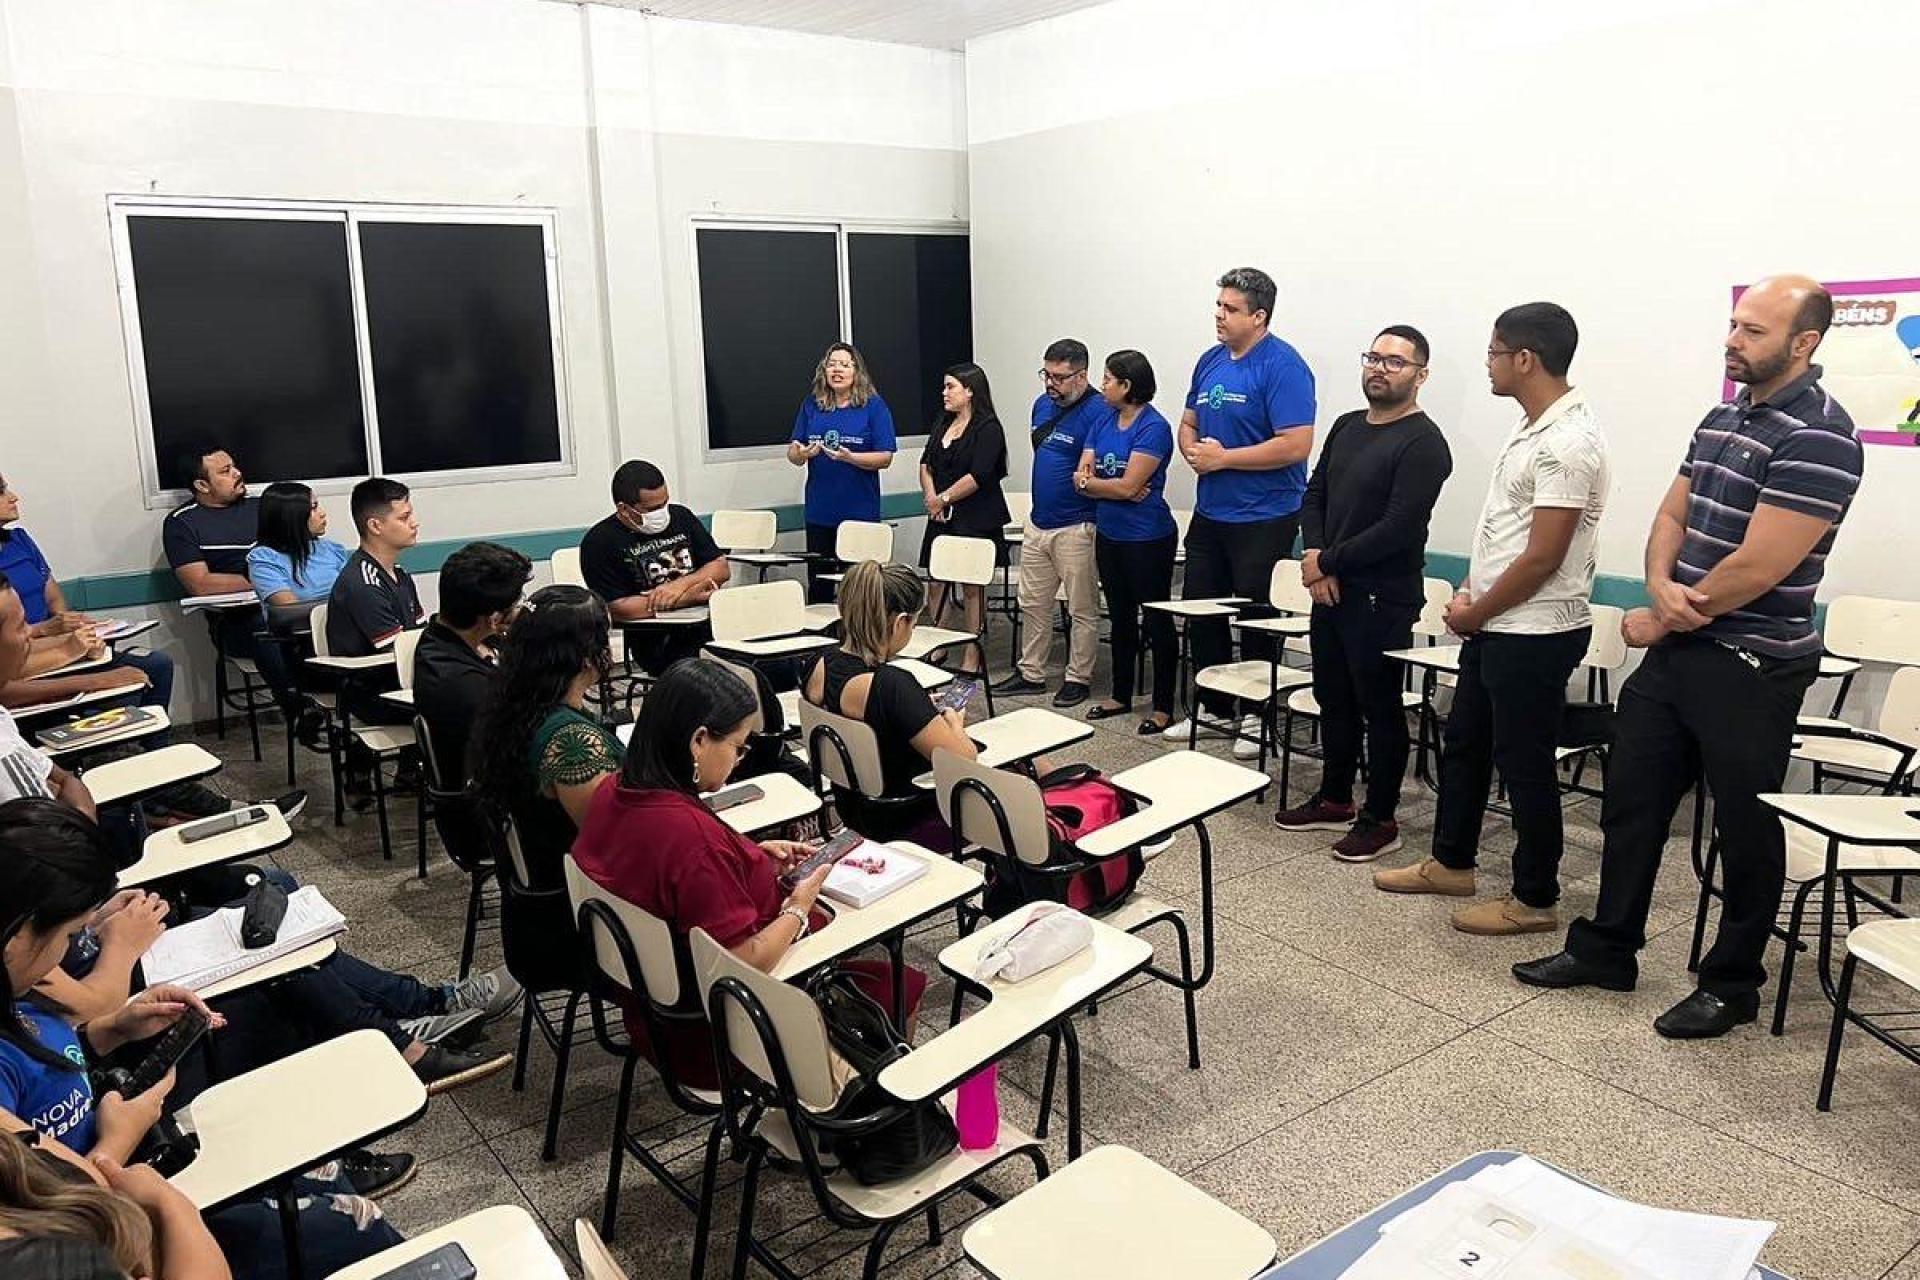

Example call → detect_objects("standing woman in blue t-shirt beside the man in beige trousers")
1073 351 1179 735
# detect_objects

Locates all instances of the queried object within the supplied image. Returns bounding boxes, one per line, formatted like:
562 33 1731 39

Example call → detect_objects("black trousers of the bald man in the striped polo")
1567 637 1820 996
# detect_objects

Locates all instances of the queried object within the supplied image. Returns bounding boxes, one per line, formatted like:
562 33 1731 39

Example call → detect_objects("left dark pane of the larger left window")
127 217 367 487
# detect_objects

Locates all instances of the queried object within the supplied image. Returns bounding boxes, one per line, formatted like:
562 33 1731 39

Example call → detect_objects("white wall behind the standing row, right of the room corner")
968 0 1920 595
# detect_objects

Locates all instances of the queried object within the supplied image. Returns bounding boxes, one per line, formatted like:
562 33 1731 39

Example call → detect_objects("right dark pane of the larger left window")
359 223 561 474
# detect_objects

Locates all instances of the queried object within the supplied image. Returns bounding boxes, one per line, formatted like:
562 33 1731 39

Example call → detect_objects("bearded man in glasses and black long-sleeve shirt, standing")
1273 324 1453 862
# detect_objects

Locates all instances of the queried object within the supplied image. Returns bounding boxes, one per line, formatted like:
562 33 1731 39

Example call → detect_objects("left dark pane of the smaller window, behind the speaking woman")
695 226 839 449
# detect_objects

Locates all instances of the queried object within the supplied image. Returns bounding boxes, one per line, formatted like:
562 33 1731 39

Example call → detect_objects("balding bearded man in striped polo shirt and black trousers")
1513 276 1862 1040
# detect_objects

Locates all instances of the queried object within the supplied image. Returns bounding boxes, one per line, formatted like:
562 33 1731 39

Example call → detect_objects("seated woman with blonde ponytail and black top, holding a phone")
801 560 979 850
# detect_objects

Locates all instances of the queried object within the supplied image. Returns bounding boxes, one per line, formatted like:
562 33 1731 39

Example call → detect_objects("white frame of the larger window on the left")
108 196 576 510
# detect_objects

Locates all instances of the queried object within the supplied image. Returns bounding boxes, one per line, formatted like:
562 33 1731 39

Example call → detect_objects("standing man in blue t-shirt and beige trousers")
993 338 1114 706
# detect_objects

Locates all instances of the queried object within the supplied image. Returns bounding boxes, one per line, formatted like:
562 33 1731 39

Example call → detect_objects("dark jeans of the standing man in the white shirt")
1434 628 1582 908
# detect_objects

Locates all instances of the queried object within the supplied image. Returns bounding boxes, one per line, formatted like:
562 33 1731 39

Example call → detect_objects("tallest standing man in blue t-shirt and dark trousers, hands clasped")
1165 267 1313 758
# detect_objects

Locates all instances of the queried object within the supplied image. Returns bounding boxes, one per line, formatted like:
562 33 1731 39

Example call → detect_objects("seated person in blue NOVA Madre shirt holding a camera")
0 800 399 1276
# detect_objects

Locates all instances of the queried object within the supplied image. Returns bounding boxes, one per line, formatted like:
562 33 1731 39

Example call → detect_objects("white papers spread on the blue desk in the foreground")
1346 1155 1774 1280
